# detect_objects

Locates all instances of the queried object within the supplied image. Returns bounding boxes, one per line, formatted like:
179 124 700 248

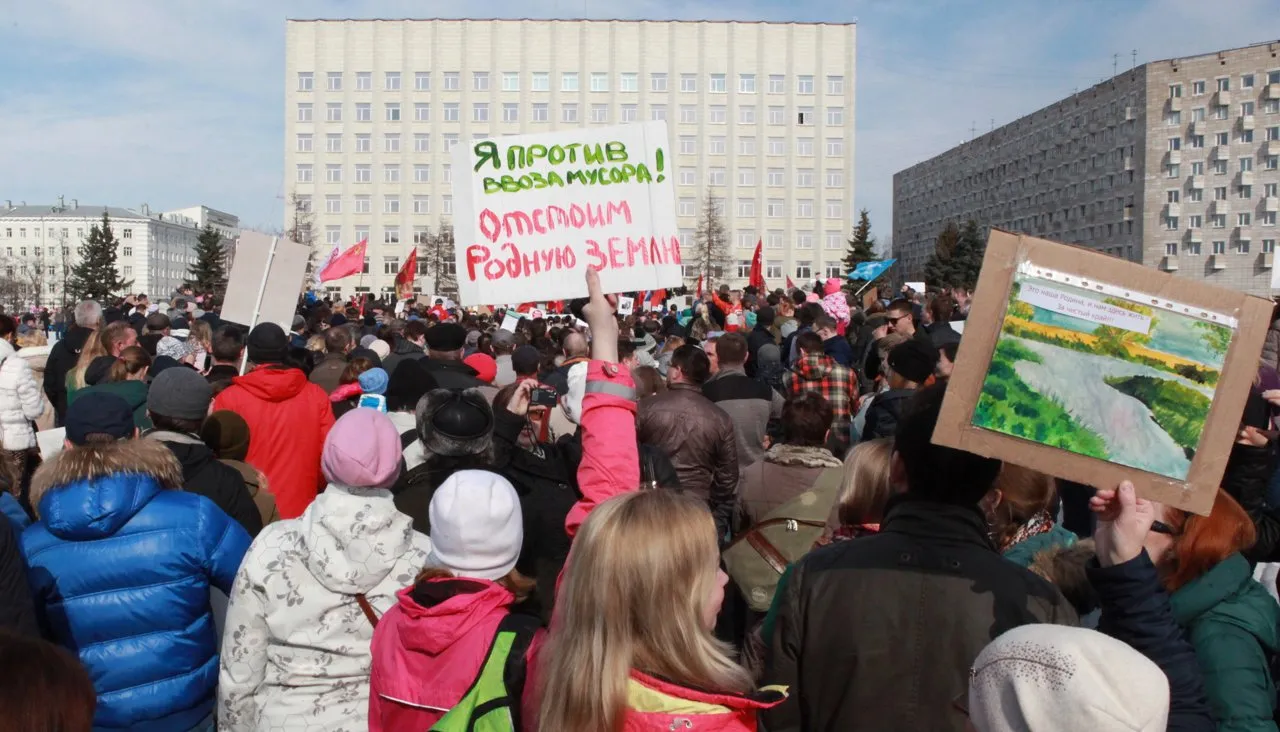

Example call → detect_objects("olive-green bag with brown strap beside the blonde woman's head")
721 467 845 613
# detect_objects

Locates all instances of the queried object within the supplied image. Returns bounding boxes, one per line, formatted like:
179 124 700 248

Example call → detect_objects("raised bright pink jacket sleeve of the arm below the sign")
564 360 640 539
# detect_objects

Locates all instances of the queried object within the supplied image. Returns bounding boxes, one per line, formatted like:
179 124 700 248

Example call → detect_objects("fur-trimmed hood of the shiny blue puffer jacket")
31 440 182 541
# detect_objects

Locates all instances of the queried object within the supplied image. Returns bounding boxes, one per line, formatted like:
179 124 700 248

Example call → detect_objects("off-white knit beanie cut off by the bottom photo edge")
969 625 1169 732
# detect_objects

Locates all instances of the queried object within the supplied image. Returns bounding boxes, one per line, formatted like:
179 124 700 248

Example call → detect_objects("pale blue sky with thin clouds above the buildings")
0 0 1280 245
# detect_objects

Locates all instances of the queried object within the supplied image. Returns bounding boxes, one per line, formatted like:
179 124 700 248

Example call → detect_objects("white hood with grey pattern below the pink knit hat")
298 481 413 595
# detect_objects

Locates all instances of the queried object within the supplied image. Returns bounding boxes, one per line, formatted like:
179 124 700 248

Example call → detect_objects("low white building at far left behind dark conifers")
0 198 239 306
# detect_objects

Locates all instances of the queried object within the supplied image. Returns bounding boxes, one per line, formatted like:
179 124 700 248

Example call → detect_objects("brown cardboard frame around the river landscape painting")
933 229 1272 516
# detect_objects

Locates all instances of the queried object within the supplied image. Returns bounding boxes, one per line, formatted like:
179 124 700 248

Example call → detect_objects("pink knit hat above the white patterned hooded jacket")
320 407 401 489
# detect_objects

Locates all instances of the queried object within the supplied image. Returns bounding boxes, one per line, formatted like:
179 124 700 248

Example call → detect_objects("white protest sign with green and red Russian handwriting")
453 122 682 305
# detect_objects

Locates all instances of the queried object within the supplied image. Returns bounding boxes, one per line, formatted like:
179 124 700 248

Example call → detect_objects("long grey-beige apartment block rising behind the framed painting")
893 41 1280 294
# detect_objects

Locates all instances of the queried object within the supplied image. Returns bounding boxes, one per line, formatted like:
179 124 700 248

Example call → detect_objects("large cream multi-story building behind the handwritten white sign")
284 19 856 293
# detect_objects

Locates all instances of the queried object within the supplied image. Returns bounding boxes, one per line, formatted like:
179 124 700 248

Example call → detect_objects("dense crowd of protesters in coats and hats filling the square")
0 276 1280 732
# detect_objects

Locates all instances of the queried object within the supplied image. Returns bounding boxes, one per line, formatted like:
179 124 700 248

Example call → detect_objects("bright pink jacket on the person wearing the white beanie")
369 578 544 732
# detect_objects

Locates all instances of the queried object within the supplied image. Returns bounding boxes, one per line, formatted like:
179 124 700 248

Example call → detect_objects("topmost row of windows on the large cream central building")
298 72 845 96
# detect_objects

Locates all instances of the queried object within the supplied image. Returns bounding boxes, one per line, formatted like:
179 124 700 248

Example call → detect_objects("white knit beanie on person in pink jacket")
428 470 525 580
